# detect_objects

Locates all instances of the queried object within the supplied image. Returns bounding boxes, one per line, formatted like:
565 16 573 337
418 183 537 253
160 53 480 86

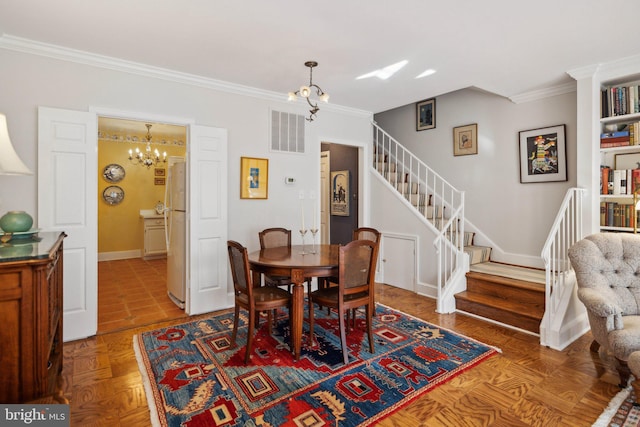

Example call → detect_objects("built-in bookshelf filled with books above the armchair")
600 80 640 232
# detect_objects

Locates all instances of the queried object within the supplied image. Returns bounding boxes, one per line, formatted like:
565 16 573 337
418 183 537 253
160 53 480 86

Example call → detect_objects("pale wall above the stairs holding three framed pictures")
371 89 576 268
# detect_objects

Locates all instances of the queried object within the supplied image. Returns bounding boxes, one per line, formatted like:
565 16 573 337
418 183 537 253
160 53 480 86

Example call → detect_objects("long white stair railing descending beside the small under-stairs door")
373 123 466 313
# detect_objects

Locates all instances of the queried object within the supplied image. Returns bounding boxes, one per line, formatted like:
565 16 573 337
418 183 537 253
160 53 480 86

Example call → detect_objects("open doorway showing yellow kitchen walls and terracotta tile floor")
97 117 187 333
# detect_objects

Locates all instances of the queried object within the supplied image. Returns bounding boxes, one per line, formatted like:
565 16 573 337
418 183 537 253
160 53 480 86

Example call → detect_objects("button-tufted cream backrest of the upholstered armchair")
569 233 640 315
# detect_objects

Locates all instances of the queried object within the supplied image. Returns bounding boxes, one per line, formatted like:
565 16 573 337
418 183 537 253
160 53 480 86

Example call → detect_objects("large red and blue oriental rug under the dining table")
133 304 498 427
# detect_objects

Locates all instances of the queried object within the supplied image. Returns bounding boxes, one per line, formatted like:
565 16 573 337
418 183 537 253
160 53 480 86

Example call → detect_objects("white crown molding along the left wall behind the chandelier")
0 34 373 118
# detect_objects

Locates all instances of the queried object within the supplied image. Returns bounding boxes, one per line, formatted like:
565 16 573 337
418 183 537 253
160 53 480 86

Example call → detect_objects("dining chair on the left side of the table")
227 240 291 365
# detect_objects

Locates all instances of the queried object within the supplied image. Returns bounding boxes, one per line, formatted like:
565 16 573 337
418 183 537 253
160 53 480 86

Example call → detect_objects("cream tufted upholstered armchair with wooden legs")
569 233 640 386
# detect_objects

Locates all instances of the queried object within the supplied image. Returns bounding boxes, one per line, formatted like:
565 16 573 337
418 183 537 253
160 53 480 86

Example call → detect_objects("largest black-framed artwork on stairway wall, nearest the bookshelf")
519 125 567 184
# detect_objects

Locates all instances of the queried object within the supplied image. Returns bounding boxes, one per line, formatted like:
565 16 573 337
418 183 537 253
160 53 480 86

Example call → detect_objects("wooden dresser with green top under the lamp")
0 232 68 403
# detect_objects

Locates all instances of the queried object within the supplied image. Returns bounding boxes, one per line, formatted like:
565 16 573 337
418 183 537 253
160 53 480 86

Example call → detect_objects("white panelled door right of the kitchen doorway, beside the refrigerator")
186 125 231 315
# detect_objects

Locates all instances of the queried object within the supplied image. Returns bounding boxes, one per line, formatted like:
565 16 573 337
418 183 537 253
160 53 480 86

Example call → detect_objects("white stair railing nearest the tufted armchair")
540 188 586 349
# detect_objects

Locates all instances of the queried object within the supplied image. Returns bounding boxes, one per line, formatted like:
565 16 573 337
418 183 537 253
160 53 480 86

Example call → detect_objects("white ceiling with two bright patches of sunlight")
0 0 640 113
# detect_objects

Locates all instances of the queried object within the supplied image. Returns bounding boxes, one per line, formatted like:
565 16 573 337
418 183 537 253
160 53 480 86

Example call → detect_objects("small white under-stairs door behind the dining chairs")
380 233 416 292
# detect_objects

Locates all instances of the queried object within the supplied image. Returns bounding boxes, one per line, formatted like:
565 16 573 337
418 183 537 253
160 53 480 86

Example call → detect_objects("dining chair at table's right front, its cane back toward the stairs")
309 240 378 365
